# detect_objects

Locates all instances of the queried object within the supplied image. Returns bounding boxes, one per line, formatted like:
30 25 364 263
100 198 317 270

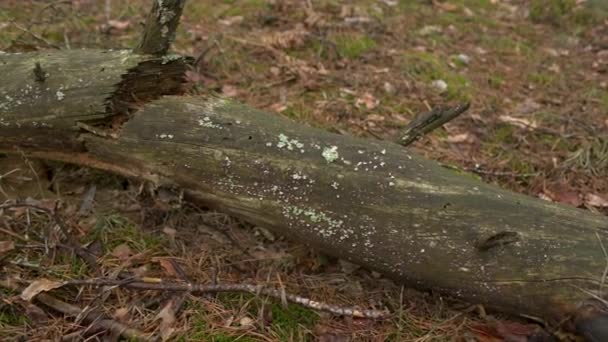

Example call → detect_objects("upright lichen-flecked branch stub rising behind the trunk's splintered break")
133 0 186 56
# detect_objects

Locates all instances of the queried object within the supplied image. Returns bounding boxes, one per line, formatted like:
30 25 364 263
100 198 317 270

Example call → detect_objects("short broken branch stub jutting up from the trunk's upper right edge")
398 102 470 146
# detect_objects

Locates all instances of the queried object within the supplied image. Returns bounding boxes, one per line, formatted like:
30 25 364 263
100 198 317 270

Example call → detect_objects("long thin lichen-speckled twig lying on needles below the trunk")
64 278 390 319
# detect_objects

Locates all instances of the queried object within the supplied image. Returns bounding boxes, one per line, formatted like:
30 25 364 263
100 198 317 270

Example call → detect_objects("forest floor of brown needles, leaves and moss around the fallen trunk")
0 0 608 342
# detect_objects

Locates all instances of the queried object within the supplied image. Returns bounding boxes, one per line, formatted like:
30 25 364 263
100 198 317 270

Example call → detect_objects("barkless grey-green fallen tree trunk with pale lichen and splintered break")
0 51 608 328
